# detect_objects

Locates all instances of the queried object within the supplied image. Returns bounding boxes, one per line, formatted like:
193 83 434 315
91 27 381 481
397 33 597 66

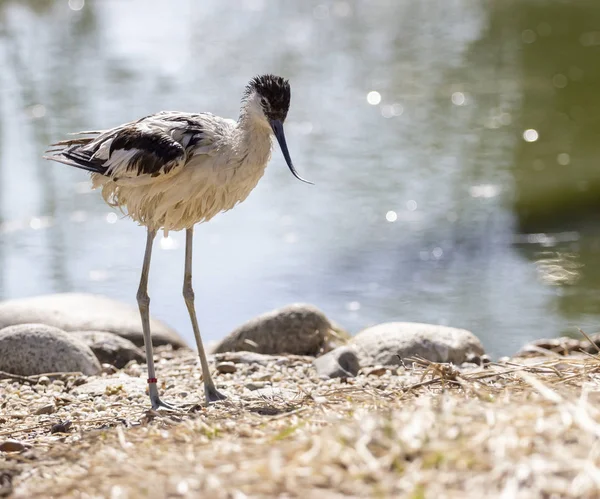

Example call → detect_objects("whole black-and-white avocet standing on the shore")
45 74 310 409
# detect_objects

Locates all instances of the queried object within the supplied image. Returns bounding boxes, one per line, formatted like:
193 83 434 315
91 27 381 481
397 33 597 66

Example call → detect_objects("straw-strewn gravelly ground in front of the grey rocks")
0 349 600 499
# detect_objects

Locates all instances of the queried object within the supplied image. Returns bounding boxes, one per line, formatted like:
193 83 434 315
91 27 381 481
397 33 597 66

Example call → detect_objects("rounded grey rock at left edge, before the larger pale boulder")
0 324 101 376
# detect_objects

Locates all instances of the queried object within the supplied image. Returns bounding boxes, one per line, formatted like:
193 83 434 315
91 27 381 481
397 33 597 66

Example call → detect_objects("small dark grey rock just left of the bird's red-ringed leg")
70 331 146 369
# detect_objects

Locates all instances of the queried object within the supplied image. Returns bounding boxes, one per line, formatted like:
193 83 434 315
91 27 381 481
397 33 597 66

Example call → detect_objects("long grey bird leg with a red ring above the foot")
137 229 174 409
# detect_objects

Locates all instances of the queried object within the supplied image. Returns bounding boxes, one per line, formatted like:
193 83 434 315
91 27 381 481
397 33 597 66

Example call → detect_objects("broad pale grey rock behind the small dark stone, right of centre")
349 322 484 367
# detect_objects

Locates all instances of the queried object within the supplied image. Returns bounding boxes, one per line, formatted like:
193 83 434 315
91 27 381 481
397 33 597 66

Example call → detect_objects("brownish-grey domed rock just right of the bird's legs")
214 304 332 356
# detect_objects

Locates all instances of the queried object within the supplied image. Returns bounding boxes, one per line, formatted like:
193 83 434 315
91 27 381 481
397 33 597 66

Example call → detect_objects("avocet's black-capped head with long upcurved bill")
243 74 312 188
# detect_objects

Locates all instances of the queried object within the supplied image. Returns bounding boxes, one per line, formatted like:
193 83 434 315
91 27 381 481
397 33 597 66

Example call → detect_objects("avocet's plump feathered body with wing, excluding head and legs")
47 111 271 231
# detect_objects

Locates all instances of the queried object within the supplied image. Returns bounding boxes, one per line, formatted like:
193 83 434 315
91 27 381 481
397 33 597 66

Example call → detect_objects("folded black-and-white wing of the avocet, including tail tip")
45 112 211 183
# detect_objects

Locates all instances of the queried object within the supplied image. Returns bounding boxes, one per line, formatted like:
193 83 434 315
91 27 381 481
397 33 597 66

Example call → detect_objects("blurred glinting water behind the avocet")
0 0 600 356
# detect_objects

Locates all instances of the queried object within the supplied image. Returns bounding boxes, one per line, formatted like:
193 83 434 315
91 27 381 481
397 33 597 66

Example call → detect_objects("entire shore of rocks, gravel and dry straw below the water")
0 294 600 499
